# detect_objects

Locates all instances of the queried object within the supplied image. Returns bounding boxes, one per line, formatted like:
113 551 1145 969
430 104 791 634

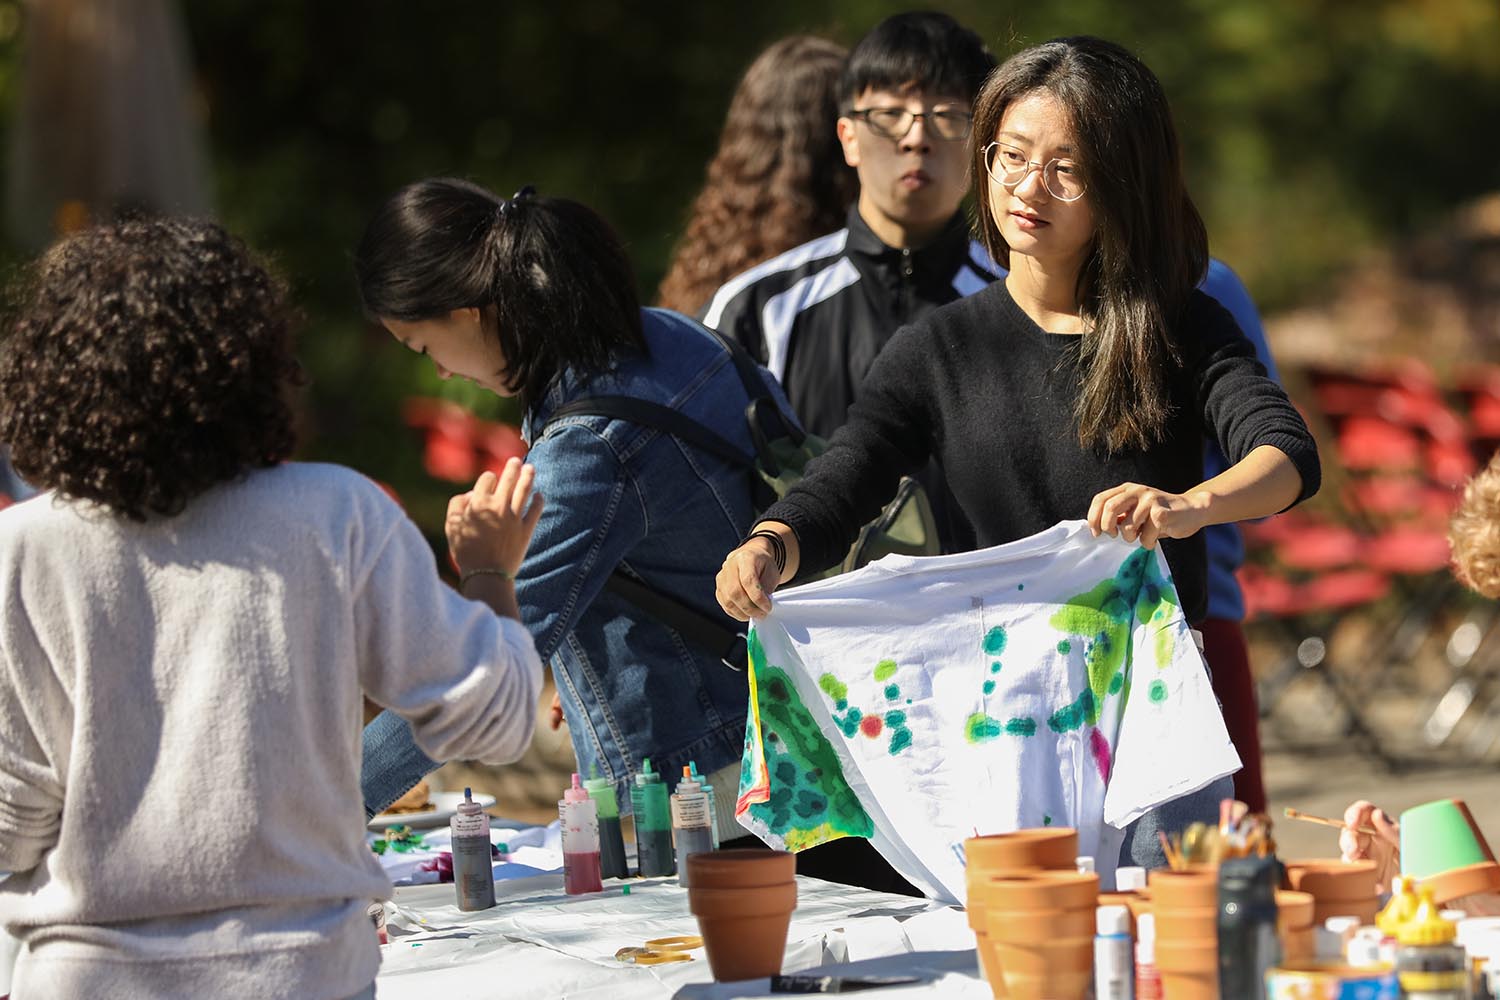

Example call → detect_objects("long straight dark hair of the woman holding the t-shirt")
971 36 1209 453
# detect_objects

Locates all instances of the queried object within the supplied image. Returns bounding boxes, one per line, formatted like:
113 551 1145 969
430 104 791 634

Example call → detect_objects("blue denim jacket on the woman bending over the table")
365 309 791 810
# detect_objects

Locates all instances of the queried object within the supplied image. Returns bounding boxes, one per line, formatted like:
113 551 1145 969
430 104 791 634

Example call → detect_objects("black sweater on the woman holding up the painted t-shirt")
764 282 1320 622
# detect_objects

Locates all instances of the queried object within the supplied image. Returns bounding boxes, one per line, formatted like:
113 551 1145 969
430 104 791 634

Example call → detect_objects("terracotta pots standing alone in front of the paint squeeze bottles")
687 850 797 982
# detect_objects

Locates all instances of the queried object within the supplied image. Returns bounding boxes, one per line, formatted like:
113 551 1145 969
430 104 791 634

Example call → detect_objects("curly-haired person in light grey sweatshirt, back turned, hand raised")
0 219 542 1000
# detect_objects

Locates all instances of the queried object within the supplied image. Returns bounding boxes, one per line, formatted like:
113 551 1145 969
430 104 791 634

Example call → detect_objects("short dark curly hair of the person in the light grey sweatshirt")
0 219 302 520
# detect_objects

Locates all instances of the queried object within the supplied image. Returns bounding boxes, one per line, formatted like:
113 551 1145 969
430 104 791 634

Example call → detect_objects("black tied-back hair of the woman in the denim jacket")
363 177 645 403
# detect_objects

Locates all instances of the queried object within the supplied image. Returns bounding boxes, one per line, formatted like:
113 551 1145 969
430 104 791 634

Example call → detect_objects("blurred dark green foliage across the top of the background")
0 0 1500 539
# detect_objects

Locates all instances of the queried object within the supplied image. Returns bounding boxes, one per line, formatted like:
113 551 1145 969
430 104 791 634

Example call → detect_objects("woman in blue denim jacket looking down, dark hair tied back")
354 178 785 814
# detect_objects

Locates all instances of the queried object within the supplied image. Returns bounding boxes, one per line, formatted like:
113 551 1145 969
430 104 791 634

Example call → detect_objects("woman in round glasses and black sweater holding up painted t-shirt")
717 37 1320 865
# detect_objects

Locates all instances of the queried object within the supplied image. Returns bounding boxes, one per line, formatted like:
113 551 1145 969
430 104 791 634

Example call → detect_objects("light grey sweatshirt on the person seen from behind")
0 463 542 1000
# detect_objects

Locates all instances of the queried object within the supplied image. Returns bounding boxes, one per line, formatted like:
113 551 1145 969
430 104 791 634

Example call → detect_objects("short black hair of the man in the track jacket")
839 10 995 111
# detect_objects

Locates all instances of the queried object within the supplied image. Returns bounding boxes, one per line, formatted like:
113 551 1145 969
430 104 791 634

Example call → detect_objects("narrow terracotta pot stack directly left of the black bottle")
1148 865 1218 1000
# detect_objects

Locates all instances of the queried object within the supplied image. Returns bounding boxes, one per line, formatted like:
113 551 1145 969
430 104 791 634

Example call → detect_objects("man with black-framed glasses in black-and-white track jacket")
704 12 998 452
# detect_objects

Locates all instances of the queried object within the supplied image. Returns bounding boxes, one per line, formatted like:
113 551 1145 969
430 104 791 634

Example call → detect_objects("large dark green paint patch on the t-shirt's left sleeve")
749 633 875 847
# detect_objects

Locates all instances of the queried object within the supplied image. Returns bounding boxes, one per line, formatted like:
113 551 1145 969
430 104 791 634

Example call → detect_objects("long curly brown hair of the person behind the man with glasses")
657 34 860 313
